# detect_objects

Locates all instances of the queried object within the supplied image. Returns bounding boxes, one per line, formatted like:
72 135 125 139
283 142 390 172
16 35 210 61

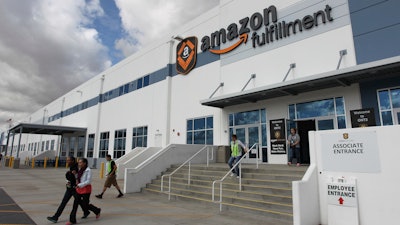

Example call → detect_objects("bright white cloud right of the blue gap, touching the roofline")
115 0 219 56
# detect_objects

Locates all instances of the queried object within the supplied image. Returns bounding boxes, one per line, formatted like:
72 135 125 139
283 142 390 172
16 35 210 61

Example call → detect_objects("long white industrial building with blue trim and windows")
0 0 400 223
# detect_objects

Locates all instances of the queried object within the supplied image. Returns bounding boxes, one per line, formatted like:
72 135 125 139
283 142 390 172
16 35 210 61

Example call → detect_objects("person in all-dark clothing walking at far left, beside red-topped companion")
47 156 90 223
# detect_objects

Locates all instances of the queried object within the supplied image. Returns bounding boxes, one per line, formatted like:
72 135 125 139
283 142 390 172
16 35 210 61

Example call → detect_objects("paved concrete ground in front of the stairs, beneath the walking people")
0 167 294 225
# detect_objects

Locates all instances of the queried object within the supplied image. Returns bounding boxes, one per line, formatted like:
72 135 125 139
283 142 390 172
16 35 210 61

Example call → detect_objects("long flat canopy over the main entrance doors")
200 56 400 108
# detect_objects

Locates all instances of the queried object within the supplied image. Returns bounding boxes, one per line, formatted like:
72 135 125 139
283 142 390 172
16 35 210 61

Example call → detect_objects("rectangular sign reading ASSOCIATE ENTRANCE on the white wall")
320 129 381 173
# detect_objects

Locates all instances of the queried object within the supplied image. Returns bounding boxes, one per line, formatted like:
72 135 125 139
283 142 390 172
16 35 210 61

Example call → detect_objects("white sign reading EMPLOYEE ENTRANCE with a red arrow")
327 178 359 225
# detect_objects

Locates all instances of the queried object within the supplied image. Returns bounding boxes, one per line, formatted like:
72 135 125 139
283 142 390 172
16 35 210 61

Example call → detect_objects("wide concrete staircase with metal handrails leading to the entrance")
143 163 307 224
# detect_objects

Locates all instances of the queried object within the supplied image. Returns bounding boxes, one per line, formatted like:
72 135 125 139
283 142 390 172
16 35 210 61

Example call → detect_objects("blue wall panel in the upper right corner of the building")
349 0 400 64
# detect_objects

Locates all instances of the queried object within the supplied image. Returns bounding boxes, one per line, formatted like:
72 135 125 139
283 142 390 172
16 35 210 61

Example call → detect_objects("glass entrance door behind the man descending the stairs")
235 125 262 163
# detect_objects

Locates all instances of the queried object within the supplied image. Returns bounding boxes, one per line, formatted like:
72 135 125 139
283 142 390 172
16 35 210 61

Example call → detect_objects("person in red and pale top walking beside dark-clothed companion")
66 158 101 225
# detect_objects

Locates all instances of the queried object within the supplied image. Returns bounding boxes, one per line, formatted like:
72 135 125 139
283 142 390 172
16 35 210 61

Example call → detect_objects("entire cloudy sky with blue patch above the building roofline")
0 0 219 132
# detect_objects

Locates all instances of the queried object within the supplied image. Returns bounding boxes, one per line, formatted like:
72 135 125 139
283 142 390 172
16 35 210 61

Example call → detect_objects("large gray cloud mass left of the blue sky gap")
0 0 111 127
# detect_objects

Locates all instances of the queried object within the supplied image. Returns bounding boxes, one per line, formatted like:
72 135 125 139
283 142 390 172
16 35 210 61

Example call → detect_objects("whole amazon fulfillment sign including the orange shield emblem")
176 5 334 75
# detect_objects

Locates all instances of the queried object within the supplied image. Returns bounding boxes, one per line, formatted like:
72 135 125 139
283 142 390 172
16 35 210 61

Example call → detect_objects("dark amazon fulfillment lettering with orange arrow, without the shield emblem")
201 5 333 54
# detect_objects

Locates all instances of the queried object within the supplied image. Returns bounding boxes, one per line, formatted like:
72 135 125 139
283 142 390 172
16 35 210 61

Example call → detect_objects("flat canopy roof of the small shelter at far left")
9 123 87 135
